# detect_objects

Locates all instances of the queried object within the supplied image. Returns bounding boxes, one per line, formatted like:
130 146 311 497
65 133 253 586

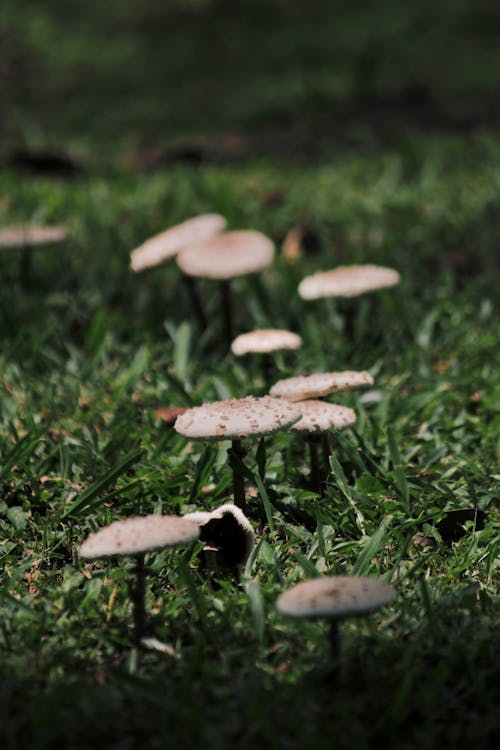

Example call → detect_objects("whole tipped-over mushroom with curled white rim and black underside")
184 503 255 572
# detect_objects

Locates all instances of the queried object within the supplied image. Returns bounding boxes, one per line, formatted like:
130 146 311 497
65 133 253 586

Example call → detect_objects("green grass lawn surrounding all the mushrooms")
0 0 500 750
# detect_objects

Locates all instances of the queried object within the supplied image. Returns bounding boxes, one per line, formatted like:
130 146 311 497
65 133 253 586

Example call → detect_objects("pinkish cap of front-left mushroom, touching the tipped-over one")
80 515 199 559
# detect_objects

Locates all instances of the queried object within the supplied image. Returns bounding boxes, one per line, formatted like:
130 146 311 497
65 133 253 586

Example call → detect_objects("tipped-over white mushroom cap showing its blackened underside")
184 503 255 567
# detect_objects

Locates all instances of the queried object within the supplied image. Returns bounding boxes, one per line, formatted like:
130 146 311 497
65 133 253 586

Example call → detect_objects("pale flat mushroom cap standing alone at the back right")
299 265 400 300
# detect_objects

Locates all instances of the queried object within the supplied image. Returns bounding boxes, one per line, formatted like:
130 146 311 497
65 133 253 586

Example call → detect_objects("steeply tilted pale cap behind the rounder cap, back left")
130 214 227 271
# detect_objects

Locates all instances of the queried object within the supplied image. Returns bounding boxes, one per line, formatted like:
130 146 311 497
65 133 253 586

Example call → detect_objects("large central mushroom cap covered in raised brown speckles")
175 396 301 440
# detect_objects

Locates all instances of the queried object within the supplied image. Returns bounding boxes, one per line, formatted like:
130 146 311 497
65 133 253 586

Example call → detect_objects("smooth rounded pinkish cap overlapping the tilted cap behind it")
177 229 274 281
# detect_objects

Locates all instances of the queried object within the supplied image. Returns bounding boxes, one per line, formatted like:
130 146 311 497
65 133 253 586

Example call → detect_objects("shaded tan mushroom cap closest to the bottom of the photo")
276 576 396 620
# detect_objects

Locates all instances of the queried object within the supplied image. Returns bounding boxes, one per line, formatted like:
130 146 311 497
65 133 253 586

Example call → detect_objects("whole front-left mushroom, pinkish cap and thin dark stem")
80 515 199 646
